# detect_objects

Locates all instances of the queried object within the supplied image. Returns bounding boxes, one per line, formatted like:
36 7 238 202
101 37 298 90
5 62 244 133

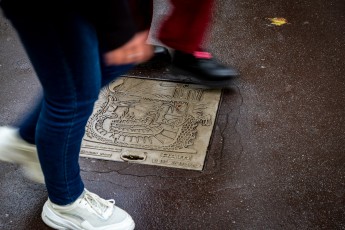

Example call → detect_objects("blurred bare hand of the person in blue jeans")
103 30 153 65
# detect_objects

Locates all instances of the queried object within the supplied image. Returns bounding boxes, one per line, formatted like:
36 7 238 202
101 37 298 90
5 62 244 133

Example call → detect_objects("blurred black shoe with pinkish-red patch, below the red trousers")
172 50 240 81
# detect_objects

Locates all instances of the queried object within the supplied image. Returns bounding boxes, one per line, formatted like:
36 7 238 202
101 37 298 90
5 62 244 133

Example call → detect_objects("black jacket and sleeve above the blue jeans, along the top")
0 0 152 52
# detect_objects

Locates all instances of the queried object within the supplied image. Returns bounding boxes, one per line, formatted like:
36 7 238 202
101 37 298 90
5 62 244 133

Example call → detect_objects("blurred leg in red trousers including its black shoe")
147 0 239 85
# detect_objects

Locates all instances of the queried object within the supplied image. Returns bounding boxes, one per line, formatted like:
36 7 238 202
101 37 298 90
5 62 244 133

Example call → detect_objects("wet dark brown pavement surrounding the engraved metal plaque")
0 0 345 230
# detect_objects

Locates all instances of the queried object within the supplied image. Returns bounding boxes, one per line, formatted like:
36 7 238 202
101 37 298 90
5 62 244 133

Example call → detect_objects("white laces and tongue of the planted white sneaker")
83 189 115 219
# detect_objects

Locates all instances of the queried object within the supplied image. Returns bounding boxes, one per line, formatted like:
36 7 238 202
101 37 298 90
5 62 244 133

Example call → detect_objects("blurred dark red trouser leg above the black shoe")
158 0 214 53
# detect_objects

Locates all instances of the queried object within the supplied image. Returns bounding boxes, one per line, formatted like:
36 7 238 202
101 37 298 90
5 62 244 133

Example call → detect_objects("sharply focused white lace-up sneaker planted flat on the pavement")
42 189 135 230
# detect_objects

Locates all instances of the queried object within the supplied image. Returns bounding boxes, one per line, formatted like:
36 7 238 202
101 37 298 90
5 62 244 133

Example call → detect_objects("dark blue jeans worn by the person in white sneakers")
9 6 133 205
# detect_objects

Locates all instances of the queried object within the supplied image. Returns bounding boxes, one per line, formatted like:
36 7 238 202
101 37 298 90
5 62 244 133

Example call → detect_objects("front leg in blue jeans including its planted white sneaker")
0 4 134 230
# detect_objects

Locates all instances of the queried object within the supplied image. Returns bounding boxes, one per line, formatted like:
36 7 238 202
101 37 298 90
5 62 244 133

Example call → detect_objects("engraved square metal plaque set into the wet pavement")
80 77 221 170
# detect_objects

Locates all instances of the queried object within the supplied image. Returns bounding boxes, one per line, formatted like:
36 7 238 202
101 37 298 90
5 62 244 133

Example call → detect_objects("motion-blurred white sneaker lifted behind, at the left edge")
0 127 44 184
